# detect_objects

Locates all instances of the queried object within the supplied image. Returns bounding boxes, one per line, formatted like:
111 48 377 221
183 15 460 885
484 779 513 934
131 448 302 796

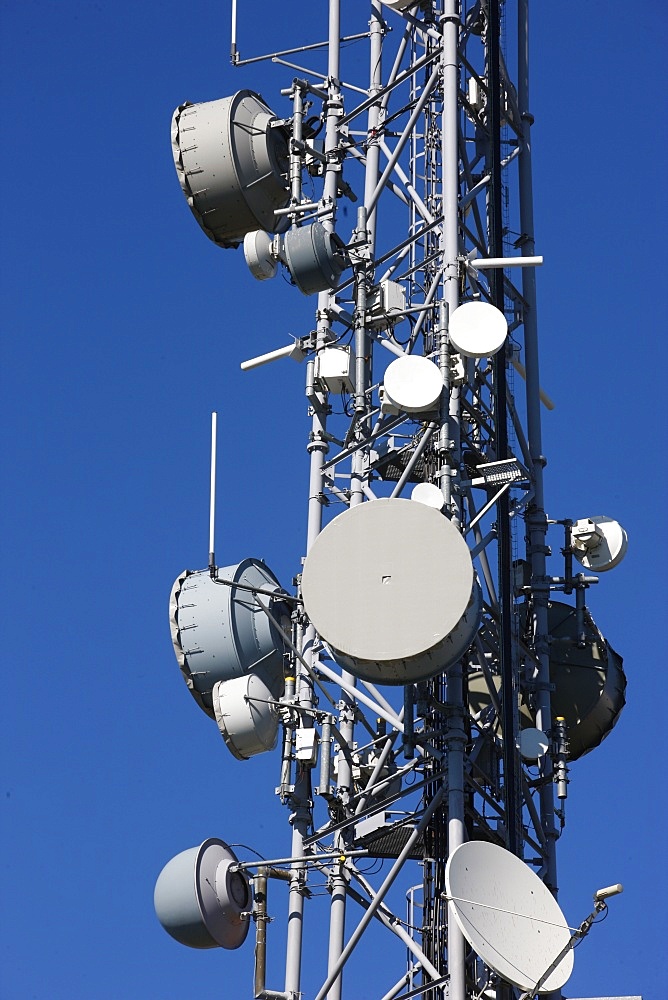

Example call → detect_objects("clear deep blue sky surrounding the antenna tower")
0 0 668 1000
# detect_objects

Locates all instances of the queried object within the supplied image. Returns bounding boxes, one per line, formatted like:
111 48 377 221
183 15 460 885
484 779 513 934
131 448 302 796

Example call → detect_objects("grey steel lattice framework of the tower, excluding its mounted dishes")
158 0 624 1000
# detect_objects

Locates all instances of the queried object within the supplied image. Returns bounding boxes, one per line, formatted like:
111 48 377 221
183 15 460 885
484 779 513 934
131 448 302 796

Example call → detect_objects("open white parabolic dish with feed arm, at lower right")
445 841 573 993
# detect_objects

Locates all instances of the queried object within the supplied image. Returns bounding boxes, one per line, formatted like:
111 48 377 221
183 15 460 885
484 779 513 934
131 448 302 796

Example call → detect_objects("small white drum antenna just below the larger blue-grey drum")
212 673 278 760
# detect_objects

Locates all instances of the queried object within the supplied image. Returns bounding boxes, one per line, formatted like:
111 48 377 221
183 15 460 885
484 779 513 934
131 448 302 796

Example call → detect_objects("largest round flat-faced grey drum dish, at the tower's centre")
302 499 479 684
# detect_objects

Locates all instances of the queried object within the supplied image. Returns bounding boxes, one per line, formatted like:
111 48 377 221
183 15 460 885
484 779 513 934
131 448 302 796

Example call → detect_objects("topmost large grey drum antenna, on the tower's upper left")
172 90 290 247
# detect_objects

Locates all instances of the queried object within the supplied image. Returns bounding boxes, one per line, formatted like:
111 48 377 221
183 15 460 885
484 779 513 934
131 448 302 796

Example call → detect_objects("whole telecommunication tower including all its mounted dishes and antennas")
155 0 627 1000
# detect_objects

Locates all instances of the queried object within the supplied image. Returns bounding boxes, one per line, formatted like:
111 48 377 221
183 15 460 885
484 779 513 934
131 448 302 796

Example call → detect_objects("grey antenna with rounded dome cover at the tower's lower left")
153 838 251 949
